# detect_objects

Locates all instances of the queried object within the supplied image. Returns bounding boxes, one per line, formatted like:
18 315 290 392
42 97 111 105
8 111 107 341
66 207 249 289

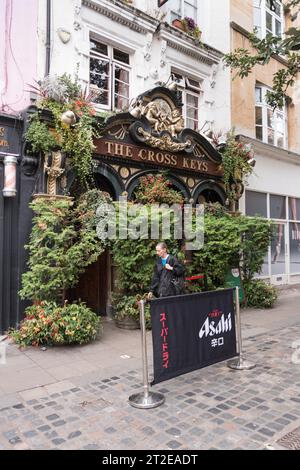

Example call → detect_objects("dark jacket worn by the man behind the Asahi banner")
150 255 185 297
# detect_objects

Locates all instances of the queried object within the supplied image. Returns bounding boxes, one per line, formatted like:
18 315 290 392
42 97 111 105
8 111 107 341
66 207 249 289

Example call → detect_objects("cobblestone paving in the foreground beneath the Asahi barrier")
0 325 300 450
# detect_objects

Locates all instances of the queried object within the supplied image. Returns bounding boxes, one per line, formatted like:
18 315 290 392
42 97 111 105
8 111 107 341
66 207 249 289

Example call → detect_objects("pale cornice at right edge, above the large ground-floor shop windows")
237 135 300 165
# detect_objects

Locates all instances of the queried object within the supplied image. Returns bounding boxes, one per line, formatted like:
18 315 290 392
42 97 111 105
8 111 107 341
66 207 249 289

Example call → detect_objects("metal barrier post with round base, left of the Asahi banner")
128 300 165 409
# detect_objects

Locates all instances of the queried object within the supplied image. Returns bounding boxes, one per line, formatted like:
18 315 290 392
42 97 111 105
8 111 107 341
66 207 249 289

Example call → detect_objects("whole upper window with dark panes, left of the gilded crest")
90 39 130 110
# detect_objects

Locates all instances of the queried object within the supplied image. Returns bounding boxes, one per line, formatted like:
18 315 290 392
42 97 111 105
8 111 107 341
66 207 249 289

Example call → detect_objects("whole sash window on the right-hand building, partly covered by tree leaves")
255 86 286 148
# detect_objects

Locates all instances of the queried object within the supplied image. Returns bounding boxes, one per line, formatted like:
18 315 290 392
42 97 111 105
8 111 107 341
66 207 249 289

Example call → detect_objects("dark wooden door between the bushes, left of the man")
69 252 109 315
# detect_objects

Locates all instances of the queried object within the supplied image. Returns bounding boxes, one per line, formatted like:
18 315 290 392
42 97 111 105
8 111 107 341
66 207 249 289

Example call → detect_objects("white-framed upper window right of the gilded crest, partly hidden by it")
173 72 201 131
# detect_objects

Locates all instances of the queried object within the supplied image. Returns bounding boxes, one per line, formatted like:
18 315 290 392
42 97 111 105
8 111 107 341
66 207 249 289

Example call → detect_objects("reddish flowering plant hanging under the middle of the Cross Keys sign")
135 174 184 205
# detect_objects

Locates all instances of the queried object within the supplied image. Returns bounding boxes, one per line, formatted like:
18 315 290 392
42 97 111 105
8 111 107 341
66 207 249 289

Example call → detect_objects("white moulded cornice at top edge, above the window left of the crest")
82 0 159 34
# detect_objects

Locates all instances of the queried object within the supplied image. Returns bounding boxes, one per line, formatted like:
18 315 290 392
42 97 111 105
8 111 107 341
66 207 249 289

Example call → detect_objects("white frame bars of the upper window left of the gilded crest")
89 36 132 111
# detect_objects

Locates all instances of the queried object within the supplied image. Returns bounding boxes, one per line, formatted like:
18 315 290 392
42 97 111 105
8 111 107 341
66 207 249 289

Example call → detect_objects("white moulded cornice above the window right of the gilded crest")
158 23 223 65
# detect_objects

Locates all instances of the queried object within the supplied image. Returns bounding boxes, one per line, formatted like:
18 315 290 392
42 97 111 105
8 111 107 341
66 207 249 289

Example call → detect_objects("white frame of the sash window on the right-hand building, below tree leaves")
255 84 287 149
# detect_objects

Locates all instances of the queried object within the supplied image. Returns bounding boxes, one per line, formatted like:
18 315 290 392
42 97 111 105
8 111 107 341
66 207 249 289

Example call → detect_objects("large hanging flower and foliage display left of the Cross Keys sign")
25 74 99 187
